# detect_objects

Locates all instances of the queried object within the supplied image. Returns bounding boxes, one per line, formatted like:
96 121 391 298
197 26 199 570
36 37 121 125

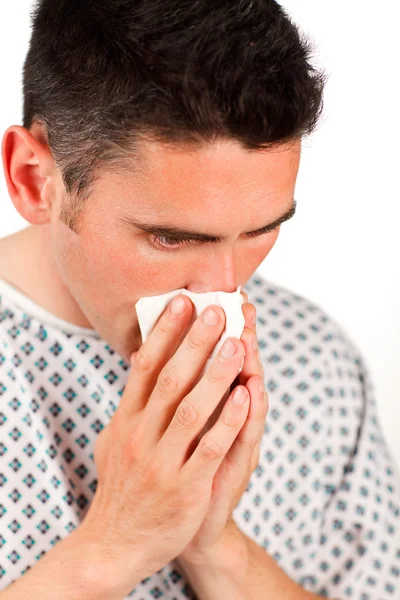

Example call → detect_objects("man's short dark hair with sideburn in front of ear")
23 0 327 228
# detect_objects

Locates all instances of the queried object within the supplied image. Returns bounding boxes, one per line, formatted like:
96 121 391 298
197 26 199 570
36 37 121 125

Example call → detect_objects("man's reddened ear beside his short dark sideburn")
2 123 57 225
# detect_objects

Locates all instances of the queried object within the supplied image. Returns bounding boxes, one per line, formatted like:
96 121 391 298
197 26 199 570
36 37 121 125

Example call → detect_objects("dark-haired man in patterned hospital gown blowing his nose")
0 0 400 600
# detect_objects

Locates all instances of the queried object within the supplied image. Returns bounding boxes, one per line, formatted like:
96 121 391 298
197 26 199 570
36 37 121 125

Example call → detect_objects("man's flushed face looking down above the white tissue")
49 137 301 360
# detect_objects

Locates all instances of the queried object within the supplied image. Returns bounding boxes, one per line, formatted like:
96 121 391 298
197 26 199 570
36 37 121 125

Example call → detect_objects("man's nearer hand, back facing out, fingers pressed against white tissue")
76 296 255 594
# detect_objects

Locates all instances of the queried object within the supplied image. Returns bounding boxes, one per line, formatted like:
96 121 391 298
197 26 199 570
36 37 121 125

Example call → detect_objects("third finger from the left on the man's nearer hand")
159 338 248 472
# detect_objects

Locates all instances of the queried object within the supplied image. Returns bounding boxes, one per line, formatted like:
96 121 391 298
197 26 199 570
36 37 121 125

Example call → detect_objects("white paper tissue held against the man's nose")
135 286 245 377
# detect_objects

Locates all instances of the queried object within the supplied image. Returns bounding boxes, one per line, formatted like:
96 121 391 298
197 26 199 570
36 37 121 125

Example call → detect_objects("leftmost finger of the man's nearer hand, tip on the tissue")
117 295 194 417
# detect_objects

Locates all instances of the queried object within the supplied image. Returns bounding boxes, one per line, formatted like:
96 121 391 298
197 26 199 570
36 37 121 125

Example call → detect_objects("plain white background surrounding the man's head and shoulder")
0 0 400 465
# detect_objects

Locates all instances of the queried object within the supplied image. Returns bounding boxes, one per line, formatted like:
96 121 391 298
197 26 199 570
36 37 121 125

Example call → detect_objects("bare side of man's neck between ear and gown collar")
0 225 92 329
